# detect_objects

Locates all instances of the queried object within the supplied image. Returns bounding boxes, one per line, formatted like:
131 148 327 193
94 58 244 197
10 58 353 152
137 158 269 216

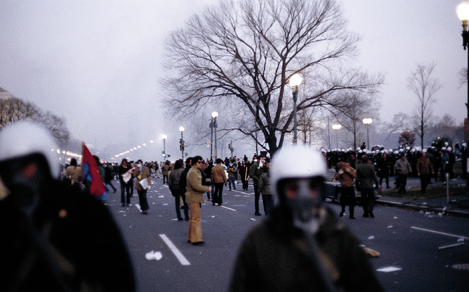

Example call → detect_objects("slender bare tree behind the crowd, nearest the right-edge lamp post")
407 63 441 148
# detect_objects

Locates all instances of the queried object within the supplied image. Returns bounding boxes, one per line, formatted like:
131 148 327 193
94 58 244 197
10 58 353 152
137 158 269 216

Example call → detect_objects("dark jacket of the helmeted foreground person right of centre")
230 206 383 292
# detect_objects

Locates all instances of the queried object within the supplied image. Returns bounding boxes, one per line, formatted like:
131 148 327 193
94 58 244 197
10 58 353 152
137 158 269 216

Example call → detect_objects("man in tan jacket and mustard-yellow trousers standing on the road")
186 156 212 245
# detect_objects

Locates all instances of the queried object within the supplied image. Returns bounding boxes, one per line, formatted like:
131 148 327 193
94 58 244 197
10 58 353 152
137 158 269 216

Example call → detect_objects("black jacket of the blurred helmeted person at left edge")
0 181 135 291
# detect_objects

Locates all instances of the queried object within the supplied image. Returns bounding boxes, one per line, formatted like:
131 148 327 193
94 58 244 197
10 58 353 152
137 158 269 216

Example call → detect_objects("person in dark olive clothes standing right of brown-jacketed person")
357 155 378 218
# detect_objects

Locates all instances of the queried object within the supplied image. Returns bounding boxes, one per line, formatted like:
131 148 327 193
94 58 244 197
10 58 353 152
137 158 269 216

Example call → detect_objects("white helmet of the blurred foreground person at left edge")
0 121 59 176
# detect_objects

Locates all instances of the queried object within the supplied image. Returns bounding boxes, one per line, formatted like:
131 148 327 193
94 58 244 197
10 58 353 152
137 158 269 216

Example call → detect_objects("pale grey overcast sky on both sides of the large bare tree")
0 0 468 160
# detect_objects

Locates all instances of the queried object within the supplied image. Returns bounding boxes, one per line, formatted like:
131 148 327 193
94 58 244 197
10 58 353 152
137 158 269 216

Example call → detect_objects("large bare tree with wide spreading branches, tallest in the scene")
162 0 383 153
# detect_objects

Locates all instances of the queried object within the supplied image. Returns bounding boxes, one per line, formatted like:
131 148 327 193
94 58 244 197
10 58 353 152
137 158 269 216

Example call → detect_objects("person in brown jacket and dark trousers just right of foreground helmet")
334 159 357 219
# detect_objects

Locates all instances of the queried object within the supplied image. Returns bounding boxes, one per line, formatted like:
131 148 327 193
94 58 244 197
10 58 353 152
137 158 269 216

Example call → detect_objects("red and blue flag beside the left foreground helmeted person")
81 143 106 197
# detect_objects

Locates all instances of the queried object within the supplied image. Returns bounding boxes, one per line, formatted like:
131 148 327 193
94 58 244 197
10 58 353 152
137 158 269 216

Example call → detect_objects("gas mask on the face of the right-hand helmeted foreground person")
287 180 323 234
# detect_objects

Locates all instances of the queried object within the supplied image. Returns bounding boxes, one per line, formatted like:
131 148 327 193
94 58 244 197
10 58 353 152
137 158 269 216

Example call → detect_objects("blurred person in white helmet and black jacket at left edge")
0 121 135 291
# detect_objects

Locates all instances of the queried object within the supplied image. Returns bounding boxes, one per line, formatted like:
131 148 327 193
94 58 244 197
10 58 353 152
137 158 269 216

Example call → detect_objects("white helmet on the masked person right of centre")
270 145 327 192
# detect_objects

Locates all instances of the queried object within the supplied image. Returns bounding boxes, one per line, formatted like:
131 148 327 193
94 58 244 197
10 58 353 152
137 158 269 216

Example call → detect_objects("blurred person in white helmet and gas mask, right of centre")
230 145 383 291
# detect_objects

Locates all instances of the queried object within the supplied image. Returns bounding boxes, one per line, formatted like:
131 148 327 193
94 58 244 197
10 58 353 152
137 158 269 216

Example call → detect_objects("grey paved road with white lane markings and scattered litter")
108 178 469 292
